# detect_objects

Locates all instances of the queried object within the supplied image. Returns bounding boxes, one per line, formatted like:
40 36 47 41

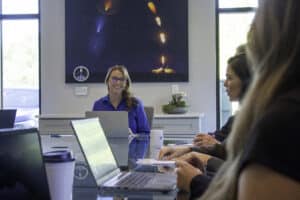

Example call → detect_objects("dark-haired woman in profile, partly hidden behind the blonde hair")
159 53 252 159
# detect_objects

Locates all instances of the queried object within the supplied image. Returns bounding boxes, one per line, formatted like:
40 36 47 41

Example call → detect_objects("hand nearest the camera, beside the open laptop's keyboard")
175 160 203 192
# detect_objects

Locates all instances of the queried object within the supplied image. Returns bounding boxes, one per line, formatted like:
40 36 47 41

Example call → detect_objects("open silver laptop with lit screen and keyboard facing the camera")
71 118 176 193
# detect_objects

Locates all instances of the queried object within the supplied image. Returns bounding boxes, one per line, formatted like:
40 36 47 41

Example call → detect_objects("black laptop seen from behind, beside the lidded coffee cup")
0 128 51 200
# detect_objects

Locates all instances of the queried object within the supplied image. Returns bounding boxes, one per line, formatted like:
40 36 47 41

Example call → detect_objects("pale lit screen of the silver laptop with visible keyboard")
72 118 118 185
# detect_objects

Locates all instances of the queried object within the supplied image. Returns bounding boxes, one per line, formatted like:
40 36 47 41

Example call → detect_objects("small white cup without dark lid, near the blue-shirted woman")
150 129 164 159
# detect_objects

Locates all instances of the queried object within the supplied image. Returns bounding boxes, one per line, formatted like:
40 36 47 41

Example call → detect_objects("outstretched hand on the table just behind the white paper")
158 146 191 160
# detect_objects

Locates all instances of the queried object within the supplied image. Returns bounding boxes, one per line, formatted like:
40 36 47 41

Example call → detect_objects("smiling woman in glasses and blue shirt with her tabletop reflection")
93 65 150 168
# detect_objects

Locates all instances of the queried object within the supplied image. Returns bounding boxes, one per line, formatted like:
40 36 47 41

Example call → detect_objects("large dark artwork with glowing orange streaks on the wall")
65 0 188 83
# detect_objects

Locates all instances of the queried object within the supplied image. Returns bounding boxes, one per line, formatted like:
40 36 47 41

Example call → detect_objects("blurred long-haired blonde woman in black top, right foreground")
201 0 300 200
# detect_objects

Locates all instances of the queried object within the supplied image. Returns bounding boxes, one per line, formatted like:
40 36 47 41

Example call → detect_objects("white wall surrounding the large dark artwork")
41 0 216 130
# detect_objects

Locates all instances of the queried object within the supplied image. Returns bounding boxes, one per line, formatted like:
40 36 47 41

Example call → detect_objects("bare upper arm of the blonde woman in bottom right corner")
238 164 300 200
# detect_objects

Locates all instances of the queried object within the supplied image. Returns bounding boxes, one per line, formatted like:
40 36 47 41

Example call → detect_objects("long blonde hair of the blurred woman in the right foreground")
201 0 300 200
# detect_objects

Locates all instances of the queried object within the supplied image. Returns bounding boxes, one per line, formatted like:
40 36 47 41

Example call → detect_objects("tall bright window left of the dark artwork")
0 0 40 125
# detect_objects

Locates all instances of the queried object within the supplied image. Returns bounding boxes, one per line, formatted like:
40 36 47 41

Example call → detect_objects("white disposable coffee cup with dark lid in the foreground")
44 150 75 200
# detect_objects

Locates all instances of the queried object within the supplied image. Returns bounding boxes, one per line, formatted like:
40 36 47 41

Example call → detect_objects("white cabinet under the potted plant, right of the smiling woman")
152 113 205 140
